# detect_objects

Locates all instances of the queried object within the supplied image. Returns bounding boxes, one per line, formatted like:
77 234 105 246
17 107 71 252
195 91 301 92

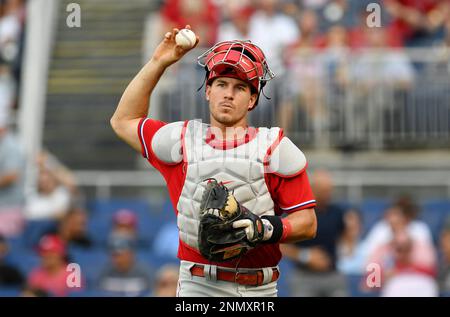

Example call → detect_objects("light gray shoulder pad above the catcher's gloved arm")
268 128 308 177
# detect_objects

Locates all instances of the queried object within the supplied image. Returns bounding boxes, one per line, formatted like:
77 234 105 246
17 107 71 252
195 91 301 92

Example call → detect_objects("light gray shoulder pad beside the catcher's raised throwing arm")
152 121 185 164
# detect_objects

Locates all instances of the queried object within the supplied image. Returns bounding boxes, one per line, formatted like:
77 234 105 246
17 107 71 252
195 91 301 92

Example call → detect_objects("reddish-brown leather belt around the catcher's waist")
190 264 280 286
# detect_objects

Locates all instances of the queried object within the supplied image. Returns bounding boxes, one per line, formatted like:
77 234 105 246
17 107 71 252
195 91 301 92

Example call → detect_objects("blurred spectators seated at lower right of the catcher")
282 171 450 297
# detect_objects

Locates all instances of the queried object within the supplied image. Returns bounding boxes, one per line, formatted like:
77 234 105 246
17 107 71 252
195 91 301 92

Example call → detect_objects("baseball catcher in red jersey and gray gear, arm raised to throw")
111 25 317 296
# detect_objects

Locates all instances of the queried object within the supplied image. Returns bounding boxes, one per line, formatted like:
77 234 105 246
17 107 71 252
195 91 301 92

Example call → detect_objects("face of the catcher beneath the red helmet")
206 77 257 127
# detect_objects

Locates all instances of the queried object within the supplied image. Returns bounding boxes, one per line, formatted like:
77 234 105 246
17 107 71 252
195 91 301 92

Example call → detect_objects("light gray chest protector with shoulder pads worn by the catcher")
152 120 306 249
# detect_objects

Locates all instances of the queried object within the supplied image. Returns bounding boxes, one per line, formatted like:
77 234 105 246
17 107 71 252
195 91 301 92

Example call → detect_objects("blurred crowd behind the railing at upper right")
157 0 450 144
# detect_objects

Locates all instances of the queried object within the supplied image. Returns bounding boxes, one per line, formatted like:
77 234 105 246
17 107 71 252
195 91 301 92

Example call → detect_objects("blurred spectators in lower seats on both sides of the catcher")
0 163 450 297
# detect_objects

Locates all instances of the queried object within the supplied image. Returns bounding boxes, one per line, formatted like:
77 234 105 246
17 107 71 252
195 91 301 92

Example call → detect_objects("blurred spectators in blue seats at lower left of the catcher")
0 190 182 297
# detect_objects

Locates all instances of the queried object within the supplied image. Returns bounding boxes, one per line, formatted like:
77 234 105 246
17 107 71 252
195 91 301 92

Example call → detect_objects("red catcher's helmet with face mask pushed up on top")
198 40 275 105
